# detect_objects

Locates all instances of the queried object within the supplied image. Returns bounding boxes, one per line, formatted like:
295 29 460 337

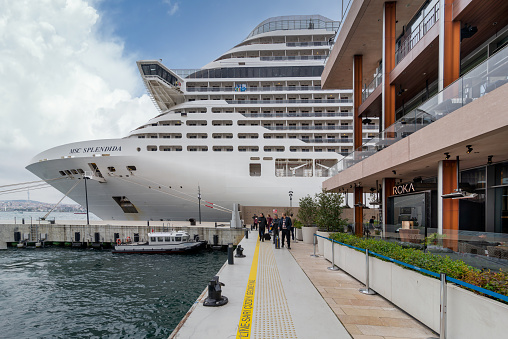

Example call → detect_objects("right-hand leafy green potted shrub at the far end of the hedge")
315 190 347 232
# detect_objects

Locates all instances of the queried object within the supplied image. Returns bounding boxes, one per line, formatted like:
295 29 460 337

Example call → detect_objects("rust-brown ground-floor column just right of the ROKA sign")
438 160 459 251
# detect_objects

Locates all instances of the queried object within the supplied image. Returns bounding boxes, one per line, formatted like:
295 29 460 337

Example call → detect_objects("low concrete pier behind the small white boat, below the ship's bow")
0 221 245 248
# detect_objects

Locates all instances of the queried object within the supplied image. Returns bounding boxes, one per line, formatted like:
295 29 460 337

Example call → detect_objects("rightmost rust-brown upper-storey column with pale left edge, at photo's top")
438 0 460 91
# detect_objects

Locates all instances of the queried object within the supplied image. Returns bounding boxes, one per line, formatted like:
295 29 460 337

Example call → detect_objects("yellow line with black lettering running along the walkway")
236 239 259 339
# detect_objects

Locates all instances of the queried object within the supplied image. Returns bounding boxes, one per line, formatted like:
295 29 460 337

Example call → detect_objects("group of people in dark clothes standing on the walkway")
251 213 295 249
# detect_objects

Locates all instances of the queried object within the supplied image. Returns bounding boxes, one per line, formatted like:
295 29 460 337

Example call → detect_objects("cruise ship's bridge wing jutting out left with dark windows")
137 60 184 112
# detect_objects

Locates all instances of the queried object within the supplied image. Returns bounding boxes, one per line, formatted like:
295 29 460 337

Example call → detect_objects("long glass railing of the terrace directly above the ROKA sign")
333 47 508 175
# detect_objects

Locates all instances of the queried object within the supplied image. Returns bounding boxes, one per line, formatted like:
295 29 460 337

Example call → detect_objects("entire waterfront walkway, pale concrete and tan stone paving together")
169 232 439 339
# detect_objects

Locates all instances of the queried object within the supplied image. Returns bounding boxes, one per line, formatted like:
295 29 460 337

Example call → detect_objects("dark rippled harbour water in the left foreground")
0 248 227 338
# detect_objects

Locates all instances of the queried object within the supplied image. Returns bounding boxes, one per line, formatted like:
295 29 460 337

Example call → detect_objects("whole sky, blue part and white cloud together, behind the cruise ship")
0 0 341 202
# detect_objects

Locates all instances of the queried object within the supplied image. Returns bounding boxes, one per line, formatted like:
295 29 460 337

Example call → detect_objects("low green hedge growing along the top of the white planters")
330 233 508 302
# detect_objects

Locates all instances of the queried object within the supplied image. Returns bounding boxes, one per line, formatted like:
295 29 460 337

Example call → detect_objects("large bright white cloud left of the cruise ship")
0 0 156 200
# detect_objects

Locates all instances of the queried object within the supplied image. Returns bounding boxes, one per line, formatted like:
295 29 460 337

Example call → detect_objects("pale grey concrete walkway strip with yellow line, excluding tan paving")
170 232 351 339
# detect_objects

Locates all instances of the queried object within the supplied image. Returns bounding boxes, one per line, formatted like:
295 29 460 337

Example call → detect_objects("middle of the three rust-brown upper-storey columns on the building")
379 2 396 129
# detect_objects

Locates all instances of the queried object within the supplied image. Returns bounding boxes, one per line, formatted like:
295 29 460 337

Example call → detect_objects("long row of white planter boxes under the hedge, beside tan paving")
323 239 508 338
